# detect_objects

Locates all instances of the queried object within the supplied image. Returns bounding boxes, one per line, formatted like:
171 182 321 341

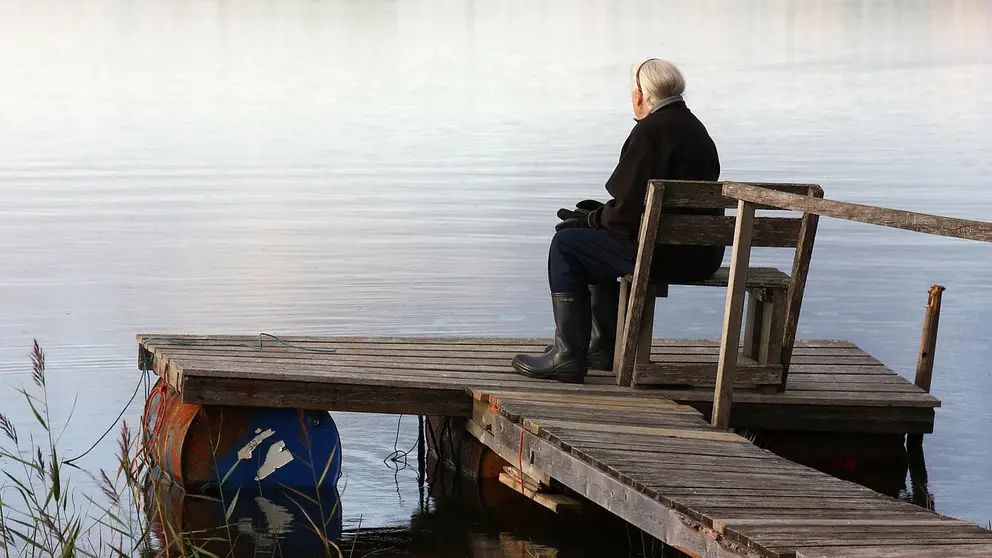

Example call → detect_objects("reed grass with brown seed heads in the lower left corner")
0 340 343 558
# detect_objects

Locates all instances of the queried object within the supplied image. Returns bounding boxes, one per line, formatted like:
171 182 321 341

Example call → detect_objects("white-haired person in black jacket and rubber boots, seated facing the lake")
513 58 724 383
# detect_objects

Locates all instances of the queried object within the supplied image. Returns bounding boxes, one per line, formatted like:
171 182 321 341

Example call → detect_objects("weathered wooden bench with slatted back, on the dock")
613 180 823 391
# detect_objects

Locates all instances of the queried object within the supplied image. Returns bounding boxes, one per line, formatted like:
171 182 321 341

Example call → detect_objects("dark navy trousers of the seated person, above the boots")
548 228 637 293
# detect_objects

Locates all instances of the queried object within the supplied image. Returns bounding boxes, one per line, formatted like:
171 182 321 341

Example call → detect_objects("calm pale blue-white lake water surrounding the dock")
0 0 992 556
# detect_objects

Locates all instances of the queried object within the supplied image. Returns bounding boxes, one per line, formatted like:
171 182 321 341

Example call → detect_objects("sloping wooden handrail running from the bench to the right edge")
723 182 992 242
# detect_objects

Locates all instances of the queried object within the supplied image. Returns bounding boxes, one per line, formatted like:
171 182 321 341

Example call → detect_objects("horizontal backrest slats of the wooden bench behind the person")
648 180 823 248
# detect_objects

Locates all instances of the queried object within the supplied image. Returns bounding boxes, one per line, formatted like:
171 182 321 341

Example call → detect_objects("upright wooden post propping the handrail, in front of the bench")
710 200 754 430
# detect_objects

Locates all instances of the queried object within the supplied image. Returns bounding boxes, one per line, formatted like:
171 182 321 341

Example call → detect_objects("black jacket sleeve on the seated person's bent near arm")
594 126 661 237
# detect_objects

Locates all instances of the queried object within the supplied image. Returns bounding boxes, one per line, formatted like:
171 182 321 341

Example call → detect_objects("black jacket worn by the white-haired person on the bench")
593 101 725 280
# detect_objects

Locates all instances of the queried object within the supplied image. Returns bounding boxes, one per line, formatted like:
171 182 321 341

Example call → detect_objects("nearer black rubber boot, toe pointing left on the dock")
513 291 592 384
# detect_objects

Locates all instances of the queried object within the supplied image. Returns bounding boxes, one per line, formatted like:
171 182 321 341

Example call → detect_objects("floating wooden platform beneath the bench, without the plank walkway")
138 335 940 434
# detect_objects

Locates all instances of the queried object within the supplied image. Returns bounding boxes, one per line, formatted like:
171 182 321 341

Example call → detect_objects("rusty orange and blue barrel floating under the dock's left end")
142 378 341 493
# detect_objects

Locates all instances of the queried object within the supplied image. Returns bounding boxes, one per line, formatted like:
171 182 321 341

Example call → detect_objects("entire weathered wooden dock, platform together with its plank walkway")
138 335 992 558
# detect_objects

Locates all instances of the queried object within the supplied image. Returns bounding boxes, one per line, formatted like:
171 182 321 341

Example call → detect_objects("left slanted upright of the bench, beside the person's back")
614 184 665 386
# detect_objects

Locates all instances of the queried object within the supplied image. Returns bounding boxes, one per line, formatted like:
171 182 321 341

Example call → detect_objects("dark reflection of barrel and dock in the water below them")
145 450 664 558
